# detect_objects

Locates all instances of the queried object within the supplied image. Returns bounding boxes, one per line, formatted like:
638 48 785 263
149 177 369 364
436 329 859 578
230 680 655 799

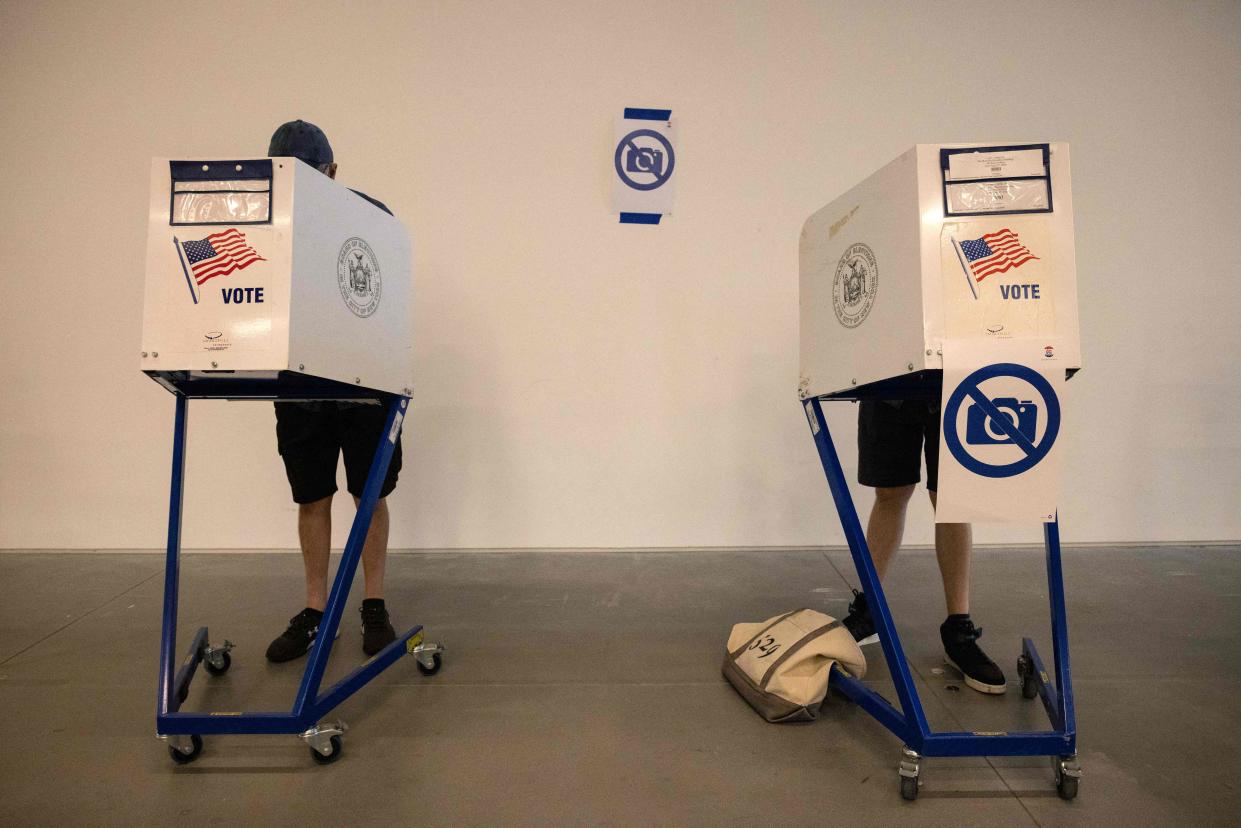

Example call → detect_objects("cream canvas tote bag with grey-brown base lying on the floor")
724 610 866 721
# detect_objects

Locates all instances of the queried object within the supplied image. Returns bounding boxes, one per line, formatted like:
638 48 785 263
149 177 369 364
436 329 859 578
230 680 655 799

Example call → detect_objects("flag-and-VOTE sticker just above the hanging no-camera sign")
939 216 1056 339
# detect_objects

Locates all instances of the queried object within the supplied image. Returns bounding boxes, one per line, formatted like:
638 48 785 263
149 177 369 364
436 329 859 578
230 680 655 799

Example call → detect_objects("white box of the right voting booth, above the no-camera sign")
799 143 1081 398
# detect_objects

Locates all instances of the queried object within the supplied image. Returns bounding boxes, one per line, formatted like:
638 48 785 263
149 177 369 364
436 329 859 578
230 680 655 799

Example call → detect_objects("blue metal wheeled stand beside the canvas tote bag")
802 371 1081 799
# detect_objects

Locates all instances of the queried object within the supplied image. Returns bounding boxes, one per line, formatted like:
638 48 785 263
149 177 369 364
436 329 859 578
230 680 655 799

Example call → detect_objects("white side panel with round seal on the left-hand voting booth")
289 164 413 395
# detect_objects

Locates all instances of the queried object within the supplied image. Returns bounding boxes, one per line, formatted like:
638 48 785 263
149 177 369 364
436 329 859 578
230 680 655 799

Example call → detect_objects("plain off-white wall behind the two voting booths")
0 0 1241 547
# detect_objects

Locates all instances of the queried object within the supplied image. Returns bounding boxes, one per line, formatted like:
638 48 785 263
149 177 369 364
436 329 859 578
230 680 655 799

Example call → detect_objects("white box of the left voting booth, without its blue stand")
141 158 413 396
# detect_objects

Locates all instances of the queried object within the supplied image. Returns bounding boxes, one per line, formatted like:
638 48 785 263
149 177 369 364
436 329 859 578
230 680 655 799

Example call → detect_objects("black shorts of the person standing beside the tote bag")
858 400 939 492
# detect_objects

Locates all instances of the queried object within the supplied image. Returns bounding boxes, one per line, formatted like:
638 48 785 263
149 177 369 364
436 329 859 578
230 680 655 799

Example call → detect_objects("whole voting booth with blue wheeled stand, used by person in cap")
140 158 443 762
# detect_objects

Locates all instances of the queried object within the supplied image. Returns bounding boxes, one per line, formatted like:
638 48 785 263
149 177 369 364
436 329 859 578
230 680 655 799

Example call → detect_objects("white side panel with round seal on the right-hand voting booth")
799 150 925 396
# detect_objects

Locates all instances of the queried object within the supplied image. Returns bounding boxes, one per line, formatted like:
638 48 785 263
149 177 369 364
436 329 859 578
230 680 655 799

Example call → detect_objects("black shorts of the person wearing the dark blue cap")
276 402 401 503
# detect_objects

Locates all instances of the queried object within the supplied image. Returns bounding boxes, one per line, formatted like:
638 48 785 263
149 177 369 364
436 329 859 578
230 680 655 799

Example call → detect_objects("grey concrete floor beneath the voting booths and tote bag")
0 547 1241 826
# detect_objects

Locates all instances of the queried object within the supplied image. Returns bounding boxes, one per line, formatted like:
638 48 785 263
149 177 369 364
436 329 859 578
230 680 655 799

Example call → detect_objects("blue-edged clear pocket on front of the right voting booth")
939 144 1052 216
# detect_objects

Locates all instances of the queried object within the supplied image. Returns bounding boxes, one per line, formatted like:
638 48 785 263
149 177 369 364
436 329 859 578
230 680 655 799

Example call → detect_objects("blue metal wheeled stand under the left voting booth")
148 371 443 763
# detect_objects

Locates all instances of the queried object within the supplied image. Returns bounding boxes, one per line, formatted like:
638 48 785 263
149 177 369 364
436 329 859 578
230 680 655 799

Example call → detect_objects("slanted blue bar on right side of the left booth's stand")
293 397 410 716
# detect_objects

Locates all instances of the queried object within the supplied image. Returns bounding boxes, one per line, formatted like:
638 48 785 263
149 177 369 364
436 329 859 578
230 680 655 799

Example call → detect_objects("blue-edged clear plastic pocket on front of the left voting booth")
169 159 272 226
